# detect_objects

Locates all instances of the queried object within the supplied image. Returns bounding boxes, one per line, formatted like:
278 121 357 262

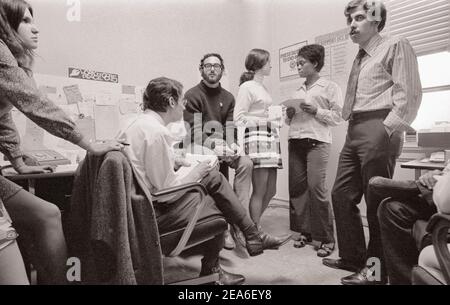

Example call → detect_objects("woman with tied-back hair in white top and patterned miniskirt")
234 49 290 249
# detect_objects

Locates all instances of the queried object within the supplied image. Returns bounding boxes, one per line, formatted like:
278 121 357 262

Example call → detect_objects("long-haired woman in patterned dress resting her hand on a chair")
0 0 123 284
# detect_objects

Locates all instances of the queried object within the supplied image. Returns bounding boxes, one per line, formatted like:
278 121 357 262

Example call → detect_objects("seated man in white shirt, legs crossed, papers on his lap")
119 77 288 284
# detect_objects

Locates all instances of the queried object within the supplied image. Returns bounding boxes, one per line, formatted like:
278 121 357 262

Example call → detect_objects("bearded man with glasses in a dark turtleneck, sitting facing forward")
184 53 253 250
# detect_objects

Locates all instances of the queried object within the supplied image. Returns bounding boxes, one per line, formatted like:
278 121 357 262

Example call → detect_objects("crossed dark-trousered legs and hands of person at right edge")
369 163 450 285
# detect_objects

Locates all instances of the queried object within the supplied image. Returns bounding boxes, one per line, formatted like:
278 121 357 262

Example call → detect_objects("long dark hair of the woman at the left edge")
0 0 33 73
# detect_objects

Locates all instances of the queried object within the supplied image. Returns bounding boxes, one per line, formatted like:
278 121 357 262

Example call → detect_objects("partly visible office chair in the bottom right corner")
412 213 450 285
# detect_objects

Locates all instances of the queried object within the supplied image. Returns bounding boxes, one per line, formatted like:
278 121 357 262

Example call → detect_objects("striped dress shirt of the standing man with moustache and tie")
353 34 422 131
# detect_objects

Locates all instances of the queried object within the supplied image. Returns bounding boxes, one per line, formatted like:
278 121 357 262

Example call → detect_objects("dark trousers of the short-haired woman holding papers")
289 139 334 243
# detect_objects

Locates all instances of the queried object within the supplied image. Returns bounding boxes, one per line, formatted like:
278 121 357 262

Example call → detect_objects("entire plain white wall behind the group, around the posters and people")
25 0 414 209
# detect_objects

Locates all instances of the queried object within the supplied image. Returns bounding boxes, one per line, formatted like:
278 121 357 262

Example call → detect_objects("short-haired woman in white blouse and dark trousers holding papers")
286 44 342 257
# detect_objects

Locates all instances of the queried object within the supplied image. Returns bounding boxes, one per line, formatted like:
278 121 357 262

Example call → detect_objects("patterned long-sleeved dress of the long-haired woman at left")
0 40 82 249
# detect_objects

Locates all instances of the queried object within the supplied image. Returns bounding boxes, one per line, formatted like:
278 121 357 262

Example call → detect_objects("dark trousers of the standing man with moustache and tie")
332 111 402 267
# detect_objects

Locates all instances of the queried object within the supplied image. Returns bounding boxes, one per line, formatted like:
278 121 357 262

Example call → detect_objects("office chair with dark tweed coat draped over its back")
68 152 227 285
